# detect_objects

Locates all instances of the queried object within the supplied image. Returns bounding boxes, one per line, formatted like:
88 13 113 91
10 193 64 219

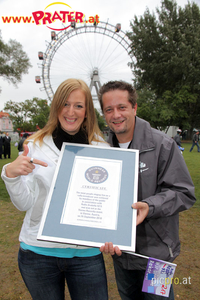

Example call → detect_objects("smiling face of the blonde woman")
58 89 86 135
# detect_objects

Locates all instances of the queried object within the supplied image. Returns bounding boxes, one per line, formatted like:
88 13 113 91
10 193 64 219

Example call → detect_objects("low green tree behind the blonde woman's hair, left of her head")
4 98 50 131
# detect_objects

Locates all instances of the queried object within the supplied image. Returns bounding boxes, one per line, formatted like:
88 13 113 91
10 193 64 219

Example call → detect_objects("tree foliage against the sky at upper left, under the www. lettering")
0 32 31 91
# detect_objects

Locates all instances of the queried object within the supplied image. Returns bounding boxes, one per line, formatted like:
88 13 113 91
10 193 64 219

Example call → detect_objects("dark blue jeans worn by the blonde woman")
18 248 108 300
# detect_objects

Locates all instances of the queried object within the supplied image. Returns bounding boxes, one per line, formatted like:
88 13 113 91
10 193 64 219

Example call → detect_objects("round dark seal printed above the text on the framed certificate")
85 166 108 183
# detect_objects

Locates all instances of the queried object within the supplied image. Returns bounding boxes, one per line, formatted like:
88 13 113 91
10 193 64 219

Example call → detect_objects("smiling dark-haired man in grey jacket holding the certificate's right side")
99 81 196 300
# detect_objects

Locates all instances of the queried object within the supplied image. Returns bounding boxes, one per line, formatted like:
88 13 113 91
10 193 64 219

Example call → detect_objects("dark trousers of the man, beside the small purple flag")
114 261 174 300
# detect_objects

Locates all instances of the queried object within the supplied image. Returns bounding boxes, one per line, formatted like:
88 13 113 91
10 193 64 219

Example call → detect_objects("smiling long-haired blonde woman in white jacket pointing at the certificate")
2 79 108 300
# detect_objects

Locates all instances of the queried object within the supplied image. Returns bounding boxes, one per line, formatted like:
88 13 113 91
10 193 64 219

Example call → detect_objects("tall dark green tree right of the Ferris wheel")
127 0 200 128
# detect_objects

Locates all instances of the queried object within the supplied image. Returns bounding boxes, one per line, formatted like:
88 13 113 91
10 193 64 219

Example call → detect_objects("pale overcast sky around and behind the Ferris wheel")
0 0 200 110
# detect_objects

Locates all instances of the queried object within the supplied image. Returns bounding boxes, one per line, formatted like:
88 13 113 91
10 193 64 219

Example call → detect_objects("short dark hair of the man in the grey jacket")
98 80 137 111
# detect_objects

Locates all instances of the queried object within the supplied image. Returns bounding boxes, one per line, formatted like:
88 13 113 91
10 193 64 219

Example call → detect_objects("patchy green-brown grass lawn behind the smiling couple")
0 143 200 300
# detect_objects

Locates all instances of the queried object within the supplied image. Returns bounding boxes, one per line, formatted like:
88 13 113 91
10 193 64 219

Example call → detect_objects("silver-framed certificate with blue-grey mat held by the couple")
38 143 139 252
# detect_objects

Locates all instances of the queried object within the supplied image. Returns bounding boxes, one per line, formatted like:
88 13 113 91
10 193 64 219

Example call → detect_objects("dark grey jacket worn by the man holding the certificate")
108 117 196 270
